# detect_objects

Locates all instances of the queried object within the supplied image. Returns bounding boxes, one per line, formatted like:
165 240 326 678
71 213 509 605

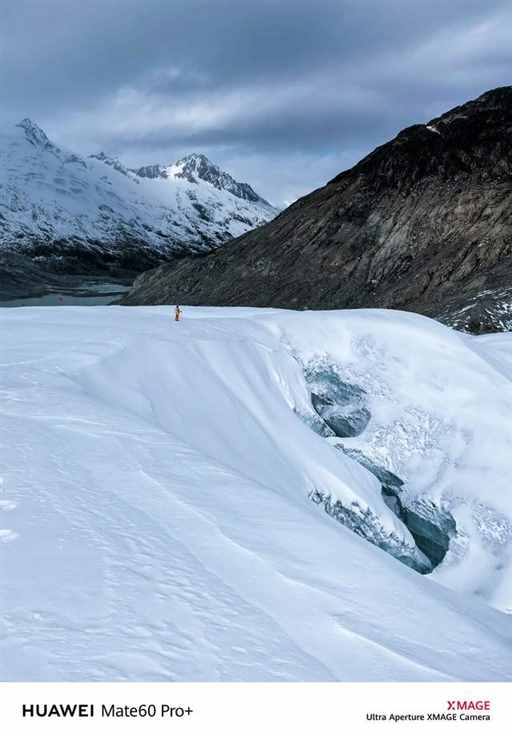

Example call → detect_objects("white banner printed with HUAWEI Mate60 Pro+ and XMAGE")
0 683 506 739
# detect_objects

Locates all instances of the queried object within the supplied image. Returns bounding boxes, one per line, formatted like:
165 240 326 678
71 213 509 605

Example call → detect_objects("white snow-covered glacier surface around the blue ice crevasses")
0 307 512 680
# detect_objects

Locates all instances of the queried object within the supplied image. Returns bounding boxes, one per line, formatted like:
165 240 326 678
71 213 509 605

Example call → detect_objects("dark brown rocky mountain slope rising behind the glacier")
125 87 512 332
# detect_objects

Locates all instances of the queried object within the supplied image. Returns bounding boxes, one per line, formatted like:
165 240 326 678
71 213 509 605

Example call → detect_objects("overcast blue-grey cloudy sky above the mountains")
0 0 512 205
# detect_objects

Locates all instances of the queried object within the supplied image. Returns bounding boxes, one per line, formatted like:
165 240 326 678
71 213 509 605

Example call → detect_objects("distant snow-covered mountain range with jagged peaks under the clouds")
0 119 277 270
